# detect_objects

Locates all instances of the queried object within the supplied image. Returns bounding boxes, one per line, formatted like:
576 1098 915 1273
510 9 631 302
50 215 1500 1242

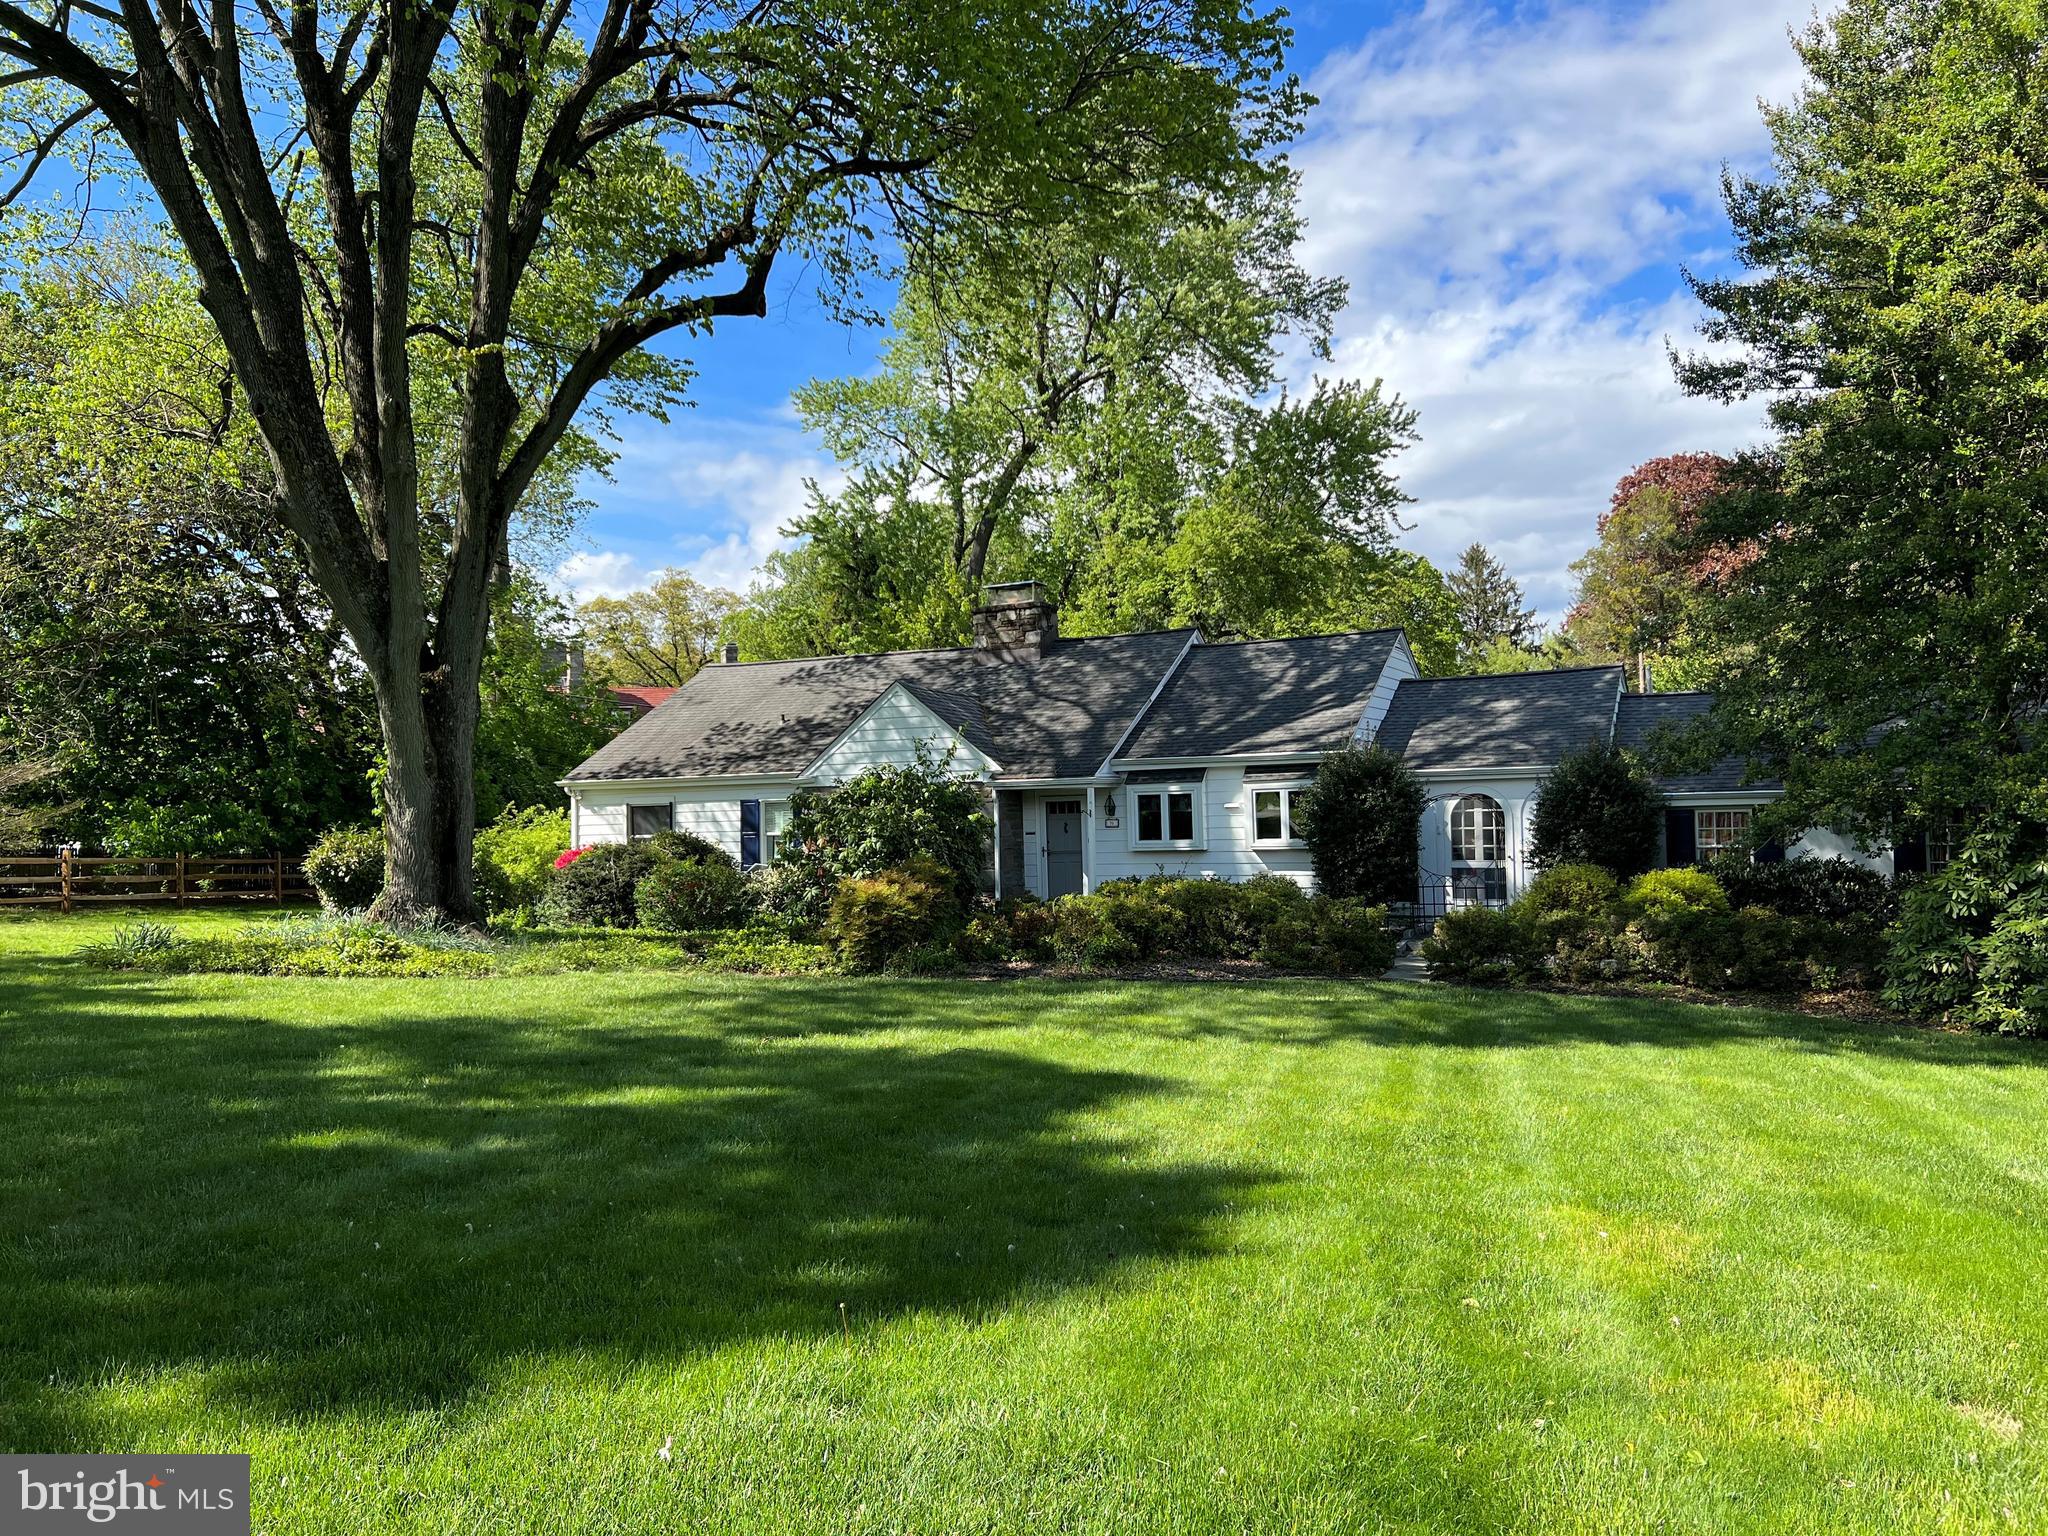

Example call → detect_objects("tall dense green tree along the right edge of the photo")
1679 0 2048 834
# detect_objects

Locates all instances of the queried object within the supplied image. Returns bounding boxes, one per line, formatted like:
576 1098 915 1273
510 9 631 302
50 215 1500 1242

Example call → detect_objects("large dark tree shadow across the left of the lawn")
0 971 1262 1450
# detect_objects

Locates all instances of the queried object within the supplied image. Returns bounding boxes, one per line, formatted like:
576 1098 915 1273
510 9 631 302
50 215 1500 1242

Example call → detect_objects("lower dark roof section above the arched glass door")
1376 666 1622 772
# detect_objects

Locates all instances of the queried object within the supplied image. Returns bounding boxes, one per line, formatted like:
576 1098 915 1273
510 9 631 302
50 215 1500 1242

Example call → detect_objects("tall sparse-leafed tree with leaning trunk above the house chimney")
797 164 1343 594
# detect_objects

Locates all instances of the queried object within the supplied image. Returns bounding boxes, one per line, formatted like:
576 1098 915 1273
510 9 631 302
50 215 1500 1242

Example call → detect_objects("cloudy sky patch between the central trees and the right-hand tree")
1296 0 1806 616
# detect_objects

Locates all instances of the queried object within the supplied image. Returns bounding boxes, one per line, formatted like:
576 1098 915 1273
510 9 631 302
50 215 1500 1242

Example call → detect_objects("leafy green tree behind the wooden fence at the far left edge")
0 240 375 854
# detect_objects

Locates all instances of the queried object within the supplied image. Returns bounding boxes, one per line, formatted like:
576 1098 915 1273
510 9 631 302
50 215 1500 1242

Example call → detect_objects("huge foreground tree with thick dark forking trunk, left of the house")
0 0 1300 915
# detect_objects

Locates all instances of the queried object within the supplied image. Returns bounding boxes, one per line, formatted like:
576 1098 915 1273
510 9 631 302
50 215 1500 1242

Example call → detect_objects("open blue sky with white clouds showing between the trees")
557 0 1810 618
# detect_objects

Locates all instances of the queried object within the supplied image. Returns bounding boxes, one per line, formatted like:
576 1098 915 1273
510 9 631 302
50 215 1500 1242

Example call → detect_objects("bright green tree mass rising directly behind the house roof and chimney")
753 154 1419 655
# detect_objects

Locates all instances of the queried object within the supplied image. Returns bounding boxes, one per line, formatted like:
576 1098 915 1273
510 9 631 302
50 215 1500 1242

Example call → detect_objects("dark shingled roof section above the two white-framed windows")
1116 629 1401 762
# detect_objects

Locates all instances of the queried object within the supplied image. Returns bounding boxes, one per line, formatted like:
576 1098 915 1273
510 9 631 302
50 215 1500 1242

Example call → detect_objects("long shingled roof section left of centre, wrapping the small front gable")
569 629 1190 780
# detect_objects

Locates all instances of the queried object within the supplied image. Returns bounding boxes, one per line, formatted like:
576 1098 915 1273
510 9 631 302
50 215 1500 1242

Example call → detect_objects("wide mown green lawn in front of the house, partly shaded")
0 913 2048 1534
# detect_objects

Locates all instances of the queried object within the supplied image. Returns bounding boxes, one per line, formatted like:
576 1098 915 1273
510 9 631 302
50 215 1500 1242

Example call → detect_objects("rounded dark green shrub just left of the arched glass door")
1294 748 1430 903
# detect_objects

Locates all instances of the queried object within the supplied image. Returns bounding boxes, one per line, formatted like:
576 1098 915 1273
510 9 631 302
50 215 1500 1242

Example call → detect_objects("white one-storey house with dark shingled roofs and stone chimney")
563 582 1939 909
